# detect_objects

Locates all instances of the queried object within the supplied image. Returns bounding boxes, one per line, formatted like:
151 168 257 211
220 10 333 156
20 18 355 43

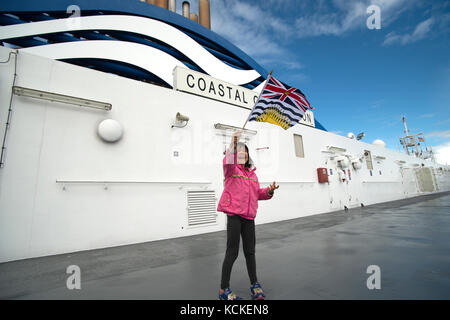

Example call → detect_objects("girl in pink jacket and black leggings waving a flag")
217 132 279 300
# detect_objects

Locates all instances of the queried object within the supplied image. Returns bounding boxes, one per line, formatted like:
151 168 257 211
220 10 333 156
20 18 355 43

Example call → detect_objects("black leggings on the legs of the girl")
220 216 257 289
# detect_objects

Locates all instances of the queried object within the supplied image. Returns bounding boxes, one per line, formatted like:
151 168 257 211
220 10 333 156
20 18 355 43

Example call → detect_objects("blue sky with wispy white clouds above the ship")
180 0 450 165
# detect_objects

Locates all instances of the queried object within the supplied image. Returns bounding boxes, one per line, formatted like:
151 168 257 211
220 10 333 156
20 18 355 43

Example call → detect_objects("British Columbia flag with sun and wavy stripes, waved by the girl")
247 75 313 130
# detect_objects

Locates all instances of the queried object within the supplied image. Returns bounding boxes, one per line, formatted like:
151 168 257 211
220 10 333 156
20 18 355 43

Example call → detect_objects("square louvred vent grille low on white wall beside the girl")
187 190 217 226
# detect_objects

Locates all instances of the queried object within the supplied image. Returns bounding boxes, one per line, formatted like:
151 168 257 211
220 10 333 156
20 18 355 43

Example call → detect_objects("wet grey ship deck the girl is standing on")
0 192 450 300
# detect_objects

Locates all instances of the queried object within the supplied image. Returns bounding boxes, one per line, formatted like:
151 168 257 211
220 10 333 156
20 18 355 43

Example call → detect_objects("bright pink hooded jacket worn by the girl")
217 150 272 220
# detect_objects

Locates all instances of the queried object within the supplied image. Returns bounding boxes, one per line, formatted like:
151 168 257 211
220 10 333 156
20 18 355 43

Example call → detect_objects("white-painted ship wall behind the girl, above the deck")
0 47 450 262
